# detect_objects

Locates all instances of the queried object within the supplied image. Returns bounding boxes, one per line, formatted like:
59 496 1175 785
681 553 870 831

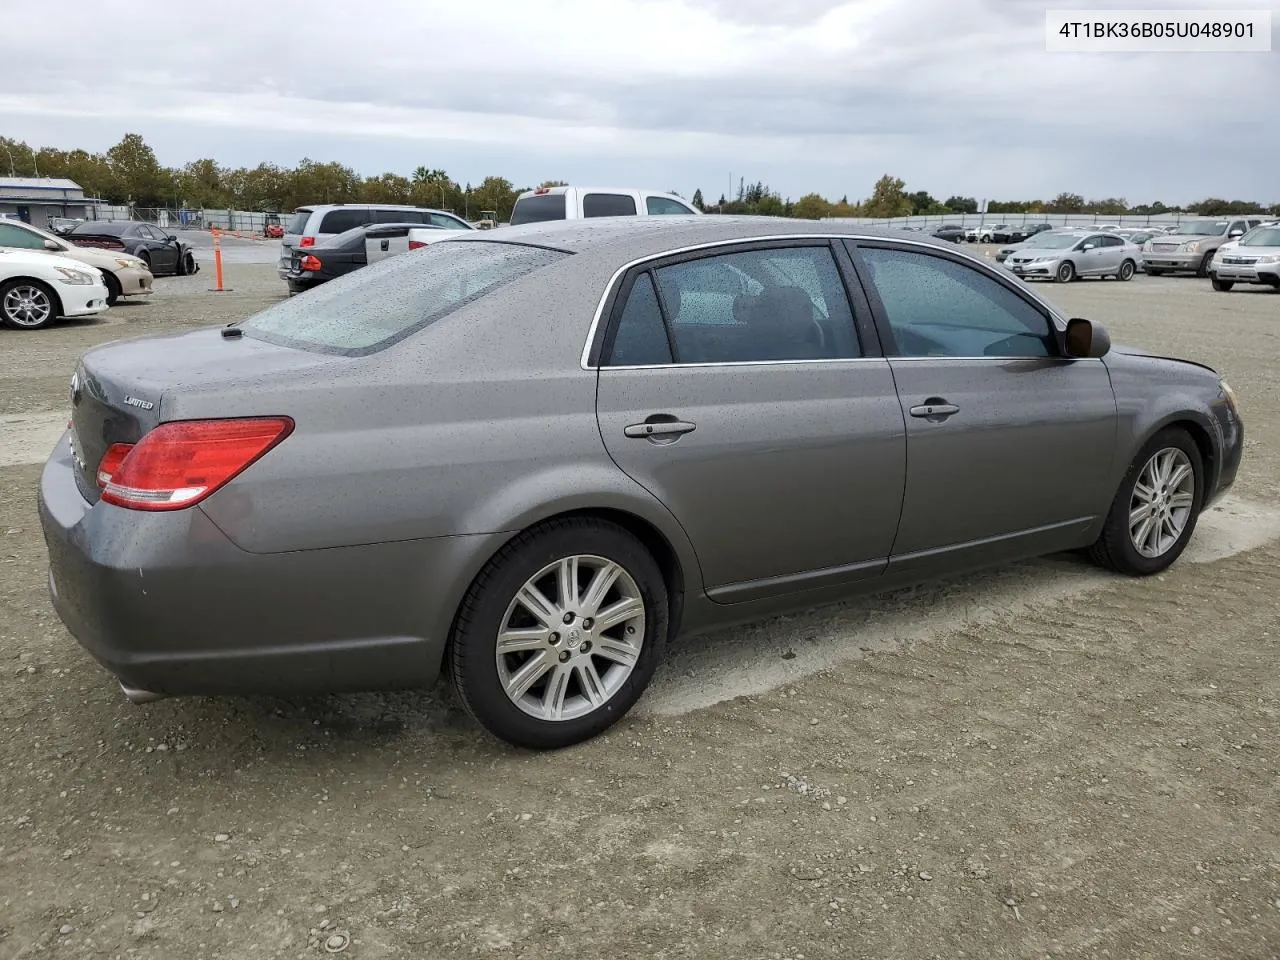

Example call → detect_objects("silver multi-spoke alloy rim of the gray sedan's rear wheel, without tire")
494 554 645 721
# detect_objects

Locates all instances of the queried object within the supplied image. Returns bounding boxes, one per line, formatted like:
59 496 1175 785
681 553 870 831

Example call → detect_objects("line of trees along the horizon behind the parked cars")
0 133 1280 220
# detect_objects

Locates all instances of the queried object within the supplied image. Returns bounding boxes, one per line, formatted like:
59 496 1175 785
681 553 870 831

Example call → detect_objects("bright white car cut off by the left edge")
0 247 106 330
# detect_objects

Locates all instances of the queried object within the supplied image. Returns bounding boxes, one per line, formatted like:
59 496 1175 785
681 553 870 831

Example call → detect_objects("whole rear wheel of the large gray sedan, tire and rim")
448 518 668 750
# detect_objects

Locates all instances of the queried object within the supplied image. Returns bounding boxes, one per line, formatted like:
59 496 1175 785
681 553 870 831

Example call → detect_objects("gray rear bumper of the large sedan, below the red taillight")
38 436 504 695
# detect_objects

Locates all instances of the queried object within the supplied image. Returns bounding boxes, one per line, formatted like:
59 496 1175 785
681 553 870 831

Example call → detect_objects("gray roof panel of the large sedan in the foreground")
444 215 955 260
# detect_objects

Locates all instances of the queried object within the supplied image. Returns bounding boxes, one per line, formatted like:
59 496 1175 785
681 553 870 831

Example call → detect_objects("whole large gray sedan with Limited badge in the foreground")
40 216 1243 748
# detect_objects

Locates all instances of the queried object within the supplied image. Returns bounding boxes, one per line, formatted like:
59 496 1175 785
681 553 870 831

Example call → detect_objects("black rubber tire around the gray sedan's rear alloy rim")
447 518 668 750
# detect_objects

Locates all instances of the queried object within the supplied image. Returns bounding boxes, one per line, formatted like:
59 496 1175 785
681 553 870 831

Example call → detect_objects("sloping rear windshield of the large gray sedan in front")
241 239 571 356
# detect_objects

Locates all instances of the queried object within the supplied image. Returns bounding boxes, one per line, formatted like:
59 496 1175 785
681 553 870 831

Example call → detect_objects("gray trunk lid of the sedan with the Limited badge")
70 328 342 503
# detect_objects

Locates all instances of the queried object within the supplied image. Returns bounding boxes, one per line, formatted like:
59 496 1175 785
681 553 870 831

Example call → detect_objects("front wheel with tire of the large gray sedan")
1089 428 1204 576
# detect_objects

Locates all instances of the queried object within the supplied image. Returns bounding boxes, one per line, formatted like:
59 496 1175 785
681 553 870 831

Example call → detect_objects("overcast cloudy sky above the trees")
0 0 1280 204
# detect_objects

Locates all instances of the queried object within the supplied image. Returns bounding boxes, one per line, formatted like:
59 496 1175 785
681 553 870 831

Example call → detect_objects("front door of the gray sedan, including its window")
855 242 1116 575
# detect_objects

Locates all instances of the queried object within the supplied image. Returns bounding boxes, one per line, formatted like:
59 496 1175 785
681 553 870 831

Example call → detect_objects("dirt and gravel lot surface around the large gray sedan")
0 257 1280 960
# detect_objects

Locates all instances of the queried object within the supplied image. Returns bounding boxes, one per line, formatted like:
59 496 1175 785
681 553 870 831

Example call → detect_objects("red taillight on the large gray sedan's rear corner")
99 417 293 511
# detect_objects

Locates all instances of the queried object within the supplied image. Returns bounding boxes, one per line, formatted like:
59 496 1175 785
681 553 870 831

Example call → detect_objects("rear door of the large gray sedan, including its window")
593 241 906 603
